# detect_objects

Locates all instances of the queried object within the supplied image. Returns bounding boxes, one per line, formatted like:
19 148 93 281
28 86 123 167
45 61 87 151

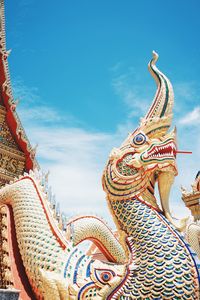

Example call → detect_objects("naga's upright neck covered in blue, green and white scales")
110 198 197 299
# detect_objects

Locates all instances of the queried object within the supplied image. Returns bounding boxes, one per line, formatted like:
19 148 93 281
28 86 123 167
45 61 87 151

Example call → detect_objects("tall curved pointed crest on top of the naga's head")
141 51 174 135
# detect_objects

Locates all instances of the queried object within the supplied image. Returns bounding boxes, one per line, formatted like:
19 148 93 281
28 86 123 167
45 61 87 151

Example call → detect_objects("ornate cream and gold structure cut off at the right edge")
181 171 200 259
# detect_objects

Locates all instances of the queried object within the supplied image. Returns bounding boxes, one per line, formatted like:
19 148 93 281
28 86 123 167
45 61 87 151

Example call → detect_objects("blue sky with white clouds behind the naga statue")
5 0 200 223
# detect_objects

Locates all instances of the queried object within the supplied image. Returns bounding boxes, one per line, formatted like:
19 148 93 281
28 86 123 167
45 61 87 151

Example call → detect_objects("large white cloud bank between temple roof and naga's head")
22 124 119 220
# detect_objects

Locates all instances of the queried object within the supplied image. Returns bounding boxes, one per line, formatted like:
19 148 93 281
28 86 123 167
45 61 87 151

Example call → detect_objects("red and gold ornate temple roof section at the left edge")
0 0 37 186
